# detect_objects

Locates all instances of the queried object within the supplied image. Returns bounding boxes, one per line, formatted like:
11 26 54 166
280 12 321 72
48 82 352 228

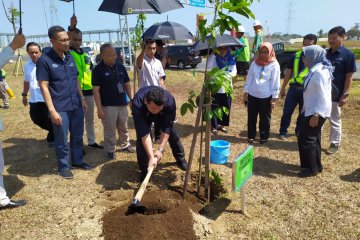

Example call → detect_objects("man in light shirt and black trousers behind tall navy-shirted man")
21 42 54 147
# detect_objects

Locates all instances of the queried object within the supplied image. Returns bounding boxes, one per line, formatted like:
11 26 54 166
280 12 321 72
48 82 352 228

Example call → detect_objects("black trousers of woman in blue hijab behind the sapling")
211 93 231 130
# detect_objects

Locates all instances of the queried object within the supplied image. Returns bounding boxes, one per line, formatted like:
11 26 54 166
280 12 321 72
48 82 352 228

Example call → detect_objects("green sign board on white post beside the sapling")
232 146 254 192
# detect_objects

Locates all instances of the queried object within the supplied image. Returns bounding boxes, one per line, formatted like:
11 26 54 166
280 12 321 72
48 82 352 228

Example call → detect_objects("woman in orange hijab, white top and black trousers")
243 42 280 144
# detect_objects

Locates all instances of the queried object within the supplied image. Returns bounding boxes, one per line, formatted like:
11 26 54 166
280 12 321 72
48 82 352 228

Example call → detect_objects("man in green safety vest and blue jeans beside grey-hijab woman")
279 34 317 140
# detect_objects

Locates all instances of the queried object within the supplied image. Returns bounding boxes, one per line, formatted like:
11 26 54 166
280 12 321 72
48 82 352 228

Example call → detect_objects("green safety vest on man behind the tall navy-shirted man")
69 50 92 90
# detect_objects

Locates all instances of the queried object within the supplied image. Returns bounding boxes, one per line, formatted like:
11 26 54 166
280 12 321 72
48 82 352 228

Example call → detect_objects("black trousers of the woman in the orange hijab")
247 94 272 140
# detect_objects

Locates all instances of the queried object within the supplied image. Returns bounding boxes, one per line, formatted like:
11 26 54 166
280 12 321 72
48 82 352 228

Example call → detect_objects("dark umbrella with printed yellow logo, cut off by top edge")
99 0 184 15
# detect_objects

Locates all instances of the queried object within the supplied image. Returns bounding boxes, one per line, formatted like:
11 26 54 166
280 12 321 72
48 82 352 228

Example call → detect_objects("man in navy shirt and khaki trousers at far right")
326 26 356 154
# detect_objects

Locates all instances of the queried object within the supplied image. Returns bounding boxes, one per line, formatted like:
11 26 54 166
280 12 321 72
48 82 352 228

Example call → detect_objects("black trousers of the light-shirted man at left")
29 102 54 142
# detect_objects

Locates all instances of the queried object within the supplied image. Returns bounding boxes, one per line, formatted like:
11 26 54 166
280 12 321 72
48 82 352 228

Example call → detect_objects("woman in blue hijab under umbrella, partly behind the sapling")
208 47 236 135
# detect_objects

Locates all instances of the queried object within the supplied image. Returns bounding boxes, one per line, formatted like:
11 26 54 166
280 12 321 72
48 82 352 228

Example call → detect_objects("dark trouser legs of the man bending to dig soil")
136 128 185 172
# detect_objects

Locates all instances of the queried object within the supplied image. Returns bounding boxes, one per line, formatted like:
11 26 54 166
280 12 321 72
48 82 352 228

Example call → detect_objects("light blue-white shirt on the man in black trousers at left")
24 61 44 103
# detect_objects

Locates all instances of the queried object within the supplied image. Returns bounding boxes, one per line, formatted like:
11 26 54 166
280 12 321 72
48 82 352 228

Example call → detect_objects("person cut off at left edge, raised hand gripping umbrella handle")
0 34 26 210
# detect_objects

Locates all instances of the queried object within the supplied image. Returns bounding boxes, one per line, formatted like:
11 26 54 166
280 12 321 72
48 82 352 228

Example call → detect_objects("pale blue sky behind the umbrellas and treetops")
0 0 360 36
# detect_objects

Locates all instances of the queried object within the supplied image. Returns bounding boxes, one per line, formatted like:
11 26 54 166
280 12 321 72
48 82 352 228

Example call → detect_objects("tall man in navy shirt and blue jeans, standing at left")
36 26 92 179
